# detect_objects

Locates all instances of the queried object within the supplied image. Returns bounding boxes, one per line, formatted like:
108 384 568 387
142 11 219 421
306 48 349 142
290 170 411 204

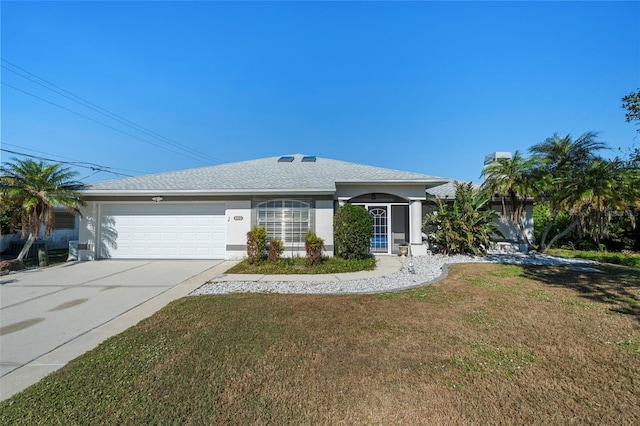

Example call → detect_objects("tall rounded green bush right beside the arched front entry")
333 204 373 259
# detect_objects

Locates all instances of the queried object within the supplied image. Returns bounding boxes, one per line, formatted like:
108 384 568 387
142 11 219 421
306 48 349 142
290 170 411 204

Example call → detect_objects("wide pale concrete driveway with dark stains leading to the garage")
0 260 230 400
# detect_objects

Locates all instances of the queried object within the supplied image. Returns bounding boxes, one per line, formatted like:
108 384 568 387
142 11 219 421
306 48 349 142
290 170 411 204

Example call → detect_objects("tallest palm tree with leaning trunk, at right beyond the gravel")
529 132 607 252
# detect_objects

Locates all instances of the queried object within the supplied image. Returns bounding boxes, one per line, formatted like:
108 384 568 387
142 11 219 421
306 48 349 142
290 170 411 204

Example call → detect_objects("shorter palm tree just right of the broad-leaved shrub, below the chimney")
482 151 538 248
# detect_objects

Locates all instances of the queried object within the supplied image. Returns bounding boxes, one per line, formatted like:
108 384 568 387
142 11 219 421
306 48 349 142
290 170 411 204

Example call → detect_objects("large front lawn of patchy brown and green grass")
0 264 640 425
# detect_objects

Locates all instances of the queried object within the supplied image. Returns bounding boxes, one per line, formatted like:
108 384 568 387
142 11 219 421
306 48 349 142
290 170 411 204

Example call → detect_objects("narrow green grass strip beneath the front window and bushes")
227 256 376 275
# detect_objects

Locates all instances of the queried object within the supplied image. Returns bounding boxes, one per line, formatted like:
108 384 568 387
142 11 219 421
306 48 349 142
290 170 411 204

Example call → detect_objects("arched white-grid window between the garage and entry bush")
257 200 311 245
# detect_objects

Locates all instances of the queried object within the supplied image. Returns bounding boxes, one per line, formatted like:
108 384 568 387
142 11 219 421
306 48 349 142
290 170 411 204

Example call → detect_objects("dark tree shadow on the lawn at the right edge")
523 265 640 322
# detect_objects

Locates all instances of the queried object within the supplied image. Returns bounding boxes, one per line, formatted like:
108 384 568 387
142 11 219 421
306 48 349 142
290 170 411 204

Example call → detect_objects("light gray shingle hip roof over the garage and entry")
85 154 448 194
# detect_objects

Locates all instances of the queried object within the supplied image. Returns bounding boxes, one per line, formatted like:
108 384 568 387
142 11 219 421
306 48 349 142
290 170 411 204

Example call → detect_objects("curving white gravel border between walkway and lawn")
191 253 598 295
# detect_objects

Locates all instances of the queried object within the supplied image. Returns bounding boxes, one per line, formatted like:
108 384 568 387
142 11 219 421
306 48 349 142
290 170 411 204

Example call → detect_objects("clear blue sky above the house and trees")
0 1 640 182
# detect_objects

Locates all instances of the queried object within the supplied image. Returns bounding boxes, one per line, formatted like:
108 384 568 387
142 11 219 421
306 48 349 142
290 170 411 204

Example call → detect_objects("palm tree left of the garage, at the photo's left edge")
0 158 84 261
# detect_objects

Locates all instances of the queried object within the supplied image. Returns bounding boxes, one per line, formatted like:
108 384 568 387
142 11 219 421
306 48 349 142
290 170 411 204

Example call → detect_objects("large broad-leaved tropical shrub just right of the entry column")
423 182 501 255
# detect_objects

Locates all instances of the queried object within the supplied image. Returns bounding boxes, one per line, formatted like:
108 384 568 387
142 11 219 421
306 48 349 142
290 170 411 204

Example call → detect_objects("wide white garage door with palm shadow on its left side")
100 203 226 259
